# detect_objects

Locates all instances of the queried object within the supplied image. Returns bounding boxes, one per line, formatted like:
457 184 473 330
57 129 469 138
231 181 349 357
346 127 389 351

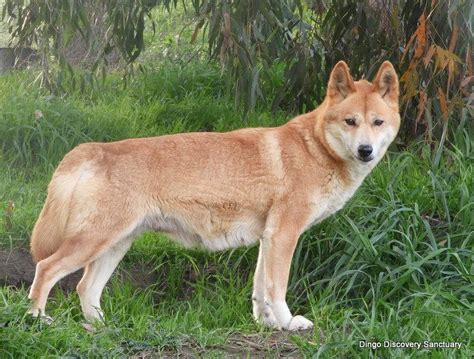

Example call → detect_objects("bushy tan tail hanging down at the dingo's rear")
31 173 77 262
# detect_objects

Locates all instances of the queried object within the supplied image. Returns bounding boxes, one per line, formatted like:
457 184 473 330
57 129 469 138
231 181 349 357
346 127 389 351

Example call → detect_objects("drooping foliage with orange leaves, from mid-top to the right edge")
191 0 474 141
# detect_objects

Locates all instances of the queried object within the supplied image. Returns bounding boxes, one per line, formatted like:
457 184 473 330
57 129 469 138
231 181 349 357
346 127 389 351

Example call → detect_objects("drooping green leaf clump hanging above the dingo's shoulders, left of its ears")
193 0 303 110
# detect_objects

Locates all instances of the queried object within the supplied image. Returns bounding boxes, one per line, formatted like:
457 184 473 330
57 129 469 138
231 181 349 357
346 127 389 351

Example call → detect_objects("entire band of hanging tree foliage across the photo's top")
4 0 474 142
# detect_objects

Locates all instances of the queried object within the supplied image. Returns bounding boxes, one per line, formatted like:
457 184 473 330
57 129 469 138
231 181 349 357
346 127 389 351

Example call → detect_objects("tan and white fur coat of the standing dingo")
30 62 400 330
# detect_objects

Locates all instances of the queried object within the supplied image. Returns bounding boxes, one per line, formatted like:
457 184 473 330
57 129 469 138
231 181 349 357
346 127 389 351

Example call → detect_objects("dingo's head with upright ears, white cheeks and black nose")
322 61 400 167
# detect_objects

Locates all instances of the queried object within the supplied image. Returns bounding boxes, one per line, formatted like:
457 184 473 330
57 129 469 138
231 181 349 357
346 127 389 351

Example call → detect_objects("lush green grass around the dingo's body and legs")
0 63 474 358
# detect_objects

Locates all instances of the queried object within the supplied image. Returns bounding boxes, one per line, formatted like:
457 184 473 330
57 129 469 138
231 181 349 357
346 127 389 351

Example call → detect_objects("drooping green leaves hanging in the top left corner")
2 0 176 93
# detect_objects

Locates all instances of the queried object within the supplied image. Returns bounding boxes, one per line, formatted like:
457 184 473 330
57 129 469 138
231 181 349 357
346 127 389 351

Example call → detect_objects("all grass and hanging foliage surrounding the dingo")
0 0 474 358
